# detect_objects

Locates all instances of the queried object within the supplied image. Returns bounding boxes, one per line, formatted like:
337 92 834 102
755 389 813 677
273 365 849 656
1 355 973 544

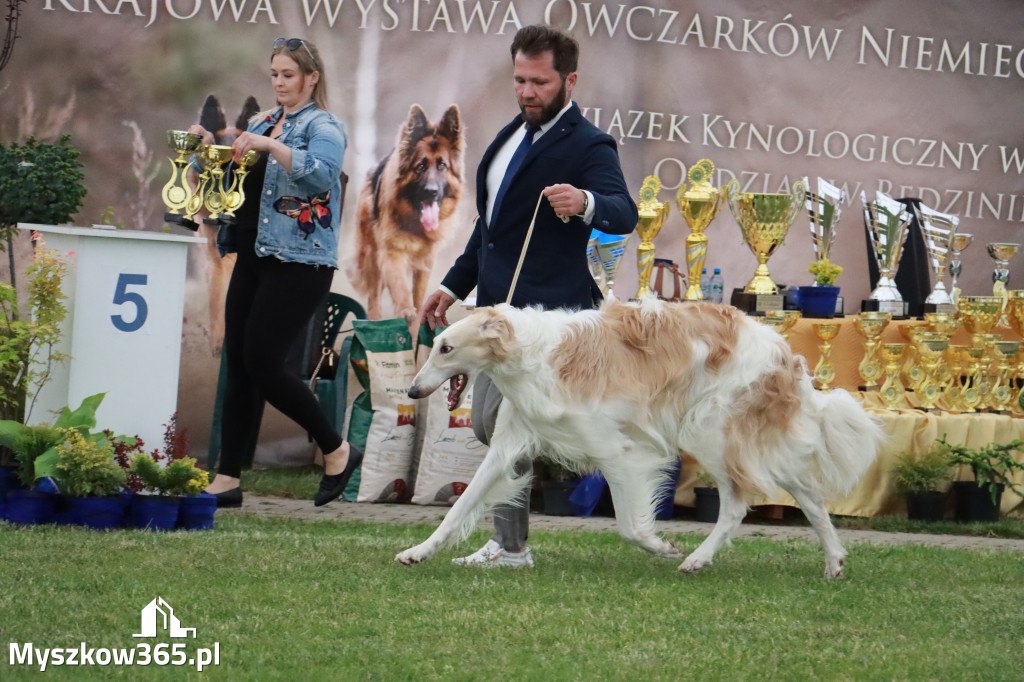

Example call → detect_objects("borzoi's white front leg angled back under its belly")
601 450 682 559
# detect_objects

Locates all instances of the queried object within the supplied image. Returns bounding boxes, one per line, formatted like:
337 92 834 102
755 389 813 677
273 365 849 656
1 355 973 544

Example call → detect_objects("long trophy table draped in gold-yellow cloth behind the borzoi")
676 314 1024 516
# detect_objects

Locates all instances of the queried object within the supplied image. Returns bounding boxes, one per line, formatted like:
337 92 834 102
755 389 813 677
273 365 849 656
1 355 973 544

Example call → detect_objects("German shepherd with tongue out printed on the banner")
349 104 464 325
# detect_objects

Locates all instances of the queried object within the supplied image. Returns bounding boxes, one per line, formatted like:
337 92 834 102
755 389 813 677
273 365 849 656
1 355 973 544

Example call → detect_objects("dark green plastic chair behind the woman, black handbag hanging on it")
207 292 367 471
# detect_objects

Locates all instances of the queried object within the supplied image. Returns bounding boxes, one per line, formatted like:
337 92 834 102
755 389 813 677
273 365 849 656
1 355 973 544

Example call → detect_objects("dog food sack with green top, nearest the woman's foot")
349 318 416 502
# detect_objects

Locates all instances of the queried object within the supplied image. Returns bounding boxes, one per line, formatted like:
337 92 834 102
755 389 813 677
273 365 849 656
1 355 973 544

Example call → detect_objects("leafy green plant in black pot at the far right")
936 436 1024 522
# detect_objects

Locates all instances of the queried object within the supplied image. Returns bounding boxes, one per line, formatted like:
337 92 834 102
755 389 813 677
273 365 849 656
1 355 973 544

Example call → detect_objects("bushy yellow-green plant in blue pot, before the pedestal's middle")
56 429 127 529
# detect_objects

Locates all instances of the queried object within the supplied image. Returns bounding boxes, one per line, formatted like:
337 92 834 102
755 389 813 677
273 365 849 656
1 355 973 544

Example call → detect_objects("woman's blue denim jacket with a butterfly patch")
217 102 346 267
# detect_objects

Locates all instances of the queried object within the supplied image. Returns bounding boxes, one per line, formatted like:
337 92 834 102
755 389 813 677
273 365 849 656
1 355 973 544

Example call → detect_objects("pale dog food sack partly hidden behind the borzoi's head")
413 326 487 506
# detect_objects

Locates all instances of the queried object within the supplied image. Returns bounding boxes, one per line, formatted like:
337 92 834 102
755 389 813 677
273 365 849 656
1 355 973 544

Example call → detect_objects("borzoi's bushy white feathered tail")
810 382 886 496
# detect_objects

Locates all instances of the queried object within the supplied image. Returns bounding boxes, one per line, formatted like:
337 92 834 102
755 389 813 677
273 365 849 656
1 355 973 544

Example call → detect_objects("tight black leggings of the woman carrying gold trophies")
217 226 342 477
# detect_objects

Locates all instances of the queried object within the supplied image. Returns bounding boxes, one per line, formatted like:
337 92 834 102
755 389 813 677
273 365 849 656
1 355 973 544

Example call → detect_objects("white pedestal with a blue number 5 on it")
18 224 206 451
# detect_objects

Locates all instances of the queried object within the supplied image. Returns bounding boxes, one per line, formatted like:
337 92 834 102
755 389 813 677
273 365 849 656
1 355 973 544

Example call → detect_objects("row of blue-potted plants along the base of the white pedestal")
0 393 217 530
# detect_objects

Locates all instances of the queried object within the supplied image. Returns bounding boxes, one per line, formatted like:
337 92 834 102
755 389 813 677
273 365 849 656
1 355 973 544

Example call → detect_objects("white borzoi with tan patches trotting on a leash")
395 297 884 578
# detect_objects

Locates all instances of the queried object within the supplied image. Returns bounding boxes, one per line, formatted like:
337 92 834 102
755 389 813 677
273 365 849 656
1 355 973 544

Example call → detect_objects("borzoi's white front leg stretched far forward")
394 444 528 566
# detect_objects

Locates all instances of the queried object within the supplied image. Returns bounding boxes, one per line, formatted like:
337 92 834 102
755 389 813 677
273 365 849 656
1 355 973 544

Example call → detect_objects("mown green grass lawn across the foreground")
0 513 1024 682
